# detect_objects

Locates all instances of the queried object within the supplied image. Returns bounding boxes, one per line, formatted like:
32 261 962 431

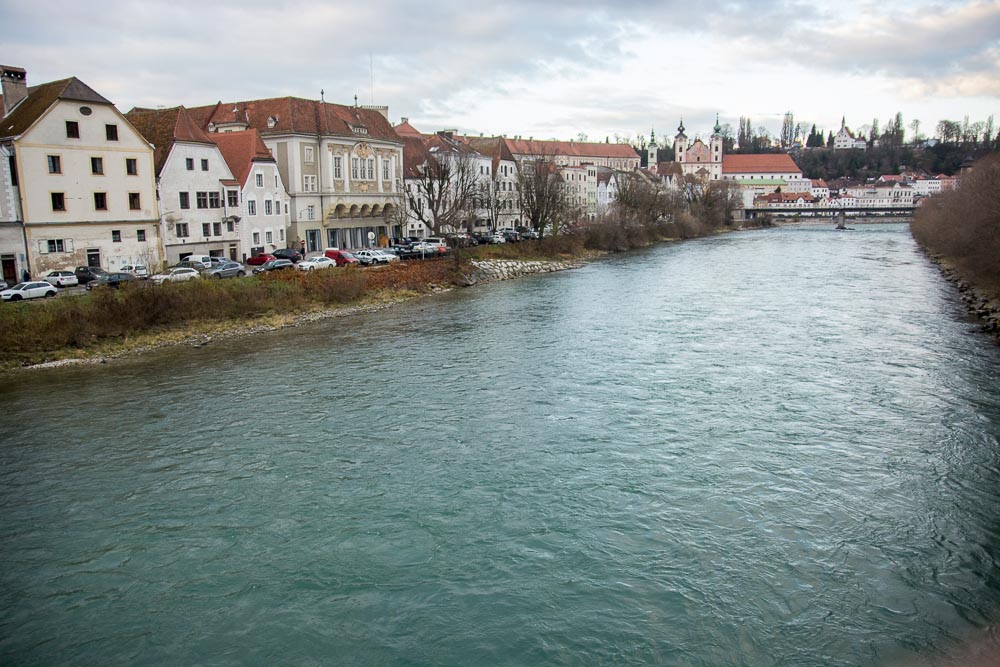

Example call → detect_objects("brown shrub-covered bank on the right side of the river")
910 154 1000 335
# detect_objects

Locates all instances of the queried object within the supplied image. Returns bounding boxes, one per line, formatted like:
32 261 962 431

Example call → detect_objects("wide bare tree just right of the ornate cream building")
404 148 479 236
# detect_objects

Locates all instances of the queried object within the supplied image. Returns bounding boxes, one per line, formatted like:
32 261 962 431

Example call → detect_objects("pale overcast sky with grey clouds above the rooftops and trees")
0 0 1000 141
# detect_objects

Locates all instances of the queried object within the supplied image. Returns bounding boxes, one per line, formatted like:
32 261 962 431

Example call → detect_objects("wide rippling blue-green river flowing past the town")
0 225 1000 667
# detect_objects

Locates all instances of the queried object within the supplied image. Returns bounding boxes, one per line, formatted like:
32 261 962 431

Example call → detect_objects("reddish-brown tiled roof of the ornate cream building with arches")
190 97 400 142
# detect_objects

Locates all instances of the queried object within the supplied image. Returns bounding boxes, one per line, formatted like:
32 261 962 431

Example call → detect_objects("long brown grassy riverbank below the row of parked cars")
0 214 736 370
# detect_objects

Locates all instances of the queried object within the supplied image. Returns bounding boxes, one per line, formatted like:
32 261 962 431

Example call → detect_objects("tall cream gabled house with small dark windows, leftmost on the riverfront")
0 73 162 276
